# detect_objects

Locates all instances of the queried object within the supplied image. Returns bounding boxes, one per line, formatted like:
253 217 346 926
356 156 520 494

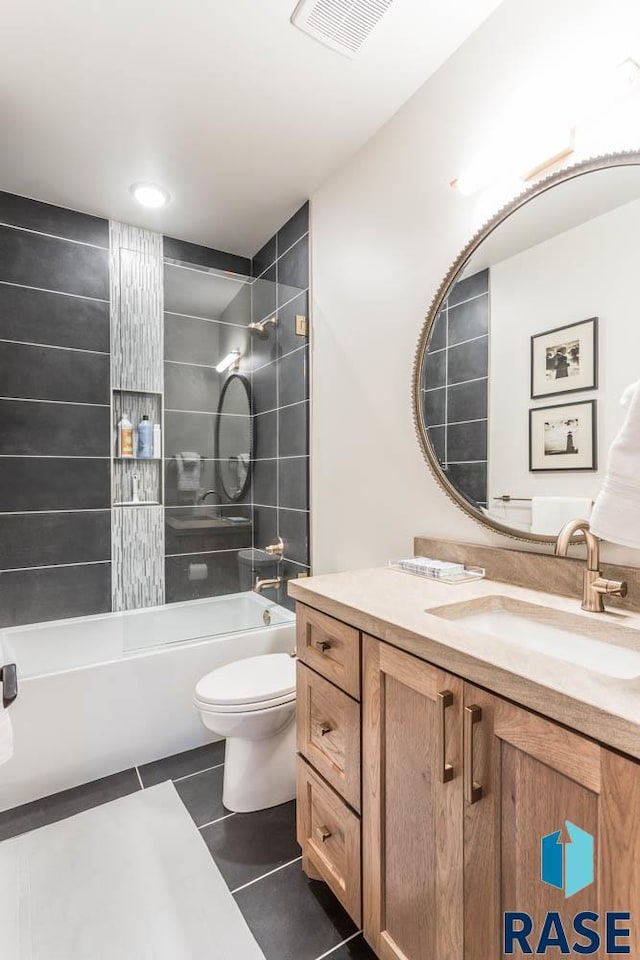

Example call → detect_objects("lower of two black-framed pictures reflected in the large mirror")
529 400 598 473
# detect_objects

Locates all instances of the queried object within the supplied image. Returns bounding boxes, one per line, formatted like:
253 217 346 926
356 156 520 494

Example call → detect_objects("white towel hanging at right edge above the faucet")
591 381 640 548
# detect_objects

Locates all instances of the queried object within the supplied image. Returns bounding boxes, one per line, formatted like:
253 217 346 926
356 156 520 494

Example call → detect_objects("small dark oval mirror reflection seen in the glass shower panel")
215 374 253 501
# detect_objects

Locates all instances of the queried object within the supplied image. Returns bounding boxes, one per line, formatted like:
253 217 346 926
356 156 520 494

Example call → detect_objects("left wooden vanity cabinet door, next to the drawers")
362 637 462 960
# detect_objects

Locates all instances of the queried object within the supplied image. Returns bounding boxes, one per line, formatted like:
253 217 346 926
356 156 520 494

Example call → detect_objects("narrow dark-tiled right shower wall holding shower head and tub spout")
251 203 309 605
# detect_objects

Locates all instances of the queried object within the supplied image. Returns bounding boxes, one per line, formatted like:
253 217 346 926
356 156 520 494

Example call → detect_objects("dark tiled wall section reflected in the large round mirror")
422 270 489 507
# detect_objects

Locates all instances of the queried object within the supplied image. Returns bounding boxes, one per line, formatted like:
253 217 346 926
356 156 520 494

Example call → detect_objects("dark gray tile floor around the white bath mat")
0 743 376 960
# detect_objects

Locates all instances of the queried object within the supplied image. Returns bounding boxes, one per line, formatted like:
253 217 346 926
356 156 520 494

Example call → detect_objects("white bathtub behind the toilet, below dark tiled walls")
0 593 295 811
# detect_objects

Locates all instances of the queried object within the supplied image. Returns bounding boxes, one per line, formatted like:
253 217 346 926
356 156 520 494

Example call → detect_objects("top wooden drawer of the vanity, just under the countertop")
296 603 360 700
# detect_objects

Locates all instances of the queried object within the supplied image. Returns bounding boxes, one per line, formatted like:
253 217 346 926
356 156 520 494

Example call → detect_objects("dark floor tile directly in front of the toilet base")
202 800 300 890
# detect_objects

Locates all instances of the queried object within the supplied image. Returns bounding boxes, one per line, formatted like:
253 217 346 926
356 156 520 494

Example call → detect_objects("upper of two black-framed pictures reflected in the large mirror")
531 317 598 400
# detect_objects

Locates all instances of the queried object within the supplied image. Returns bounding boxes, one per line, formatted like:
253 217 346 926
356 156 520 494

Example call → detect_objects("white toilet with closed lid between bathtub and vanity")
194 653 296 813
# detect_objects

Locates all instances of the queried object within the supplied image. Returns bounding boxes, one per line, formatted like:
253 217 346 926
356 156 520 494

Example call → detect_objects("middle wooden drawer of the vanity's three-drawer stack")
296 661 360 811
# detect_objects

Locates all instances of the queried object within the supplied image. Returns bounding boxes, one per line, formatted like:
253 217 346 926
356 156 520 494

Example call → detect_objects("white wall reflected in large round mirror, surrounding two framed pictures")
489 201 640 522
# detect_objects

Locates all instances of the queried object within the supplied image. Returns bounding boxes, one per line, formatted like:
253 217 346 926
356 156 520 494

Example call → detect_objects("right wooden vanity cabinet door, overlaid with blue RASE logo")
463 684 640 960
